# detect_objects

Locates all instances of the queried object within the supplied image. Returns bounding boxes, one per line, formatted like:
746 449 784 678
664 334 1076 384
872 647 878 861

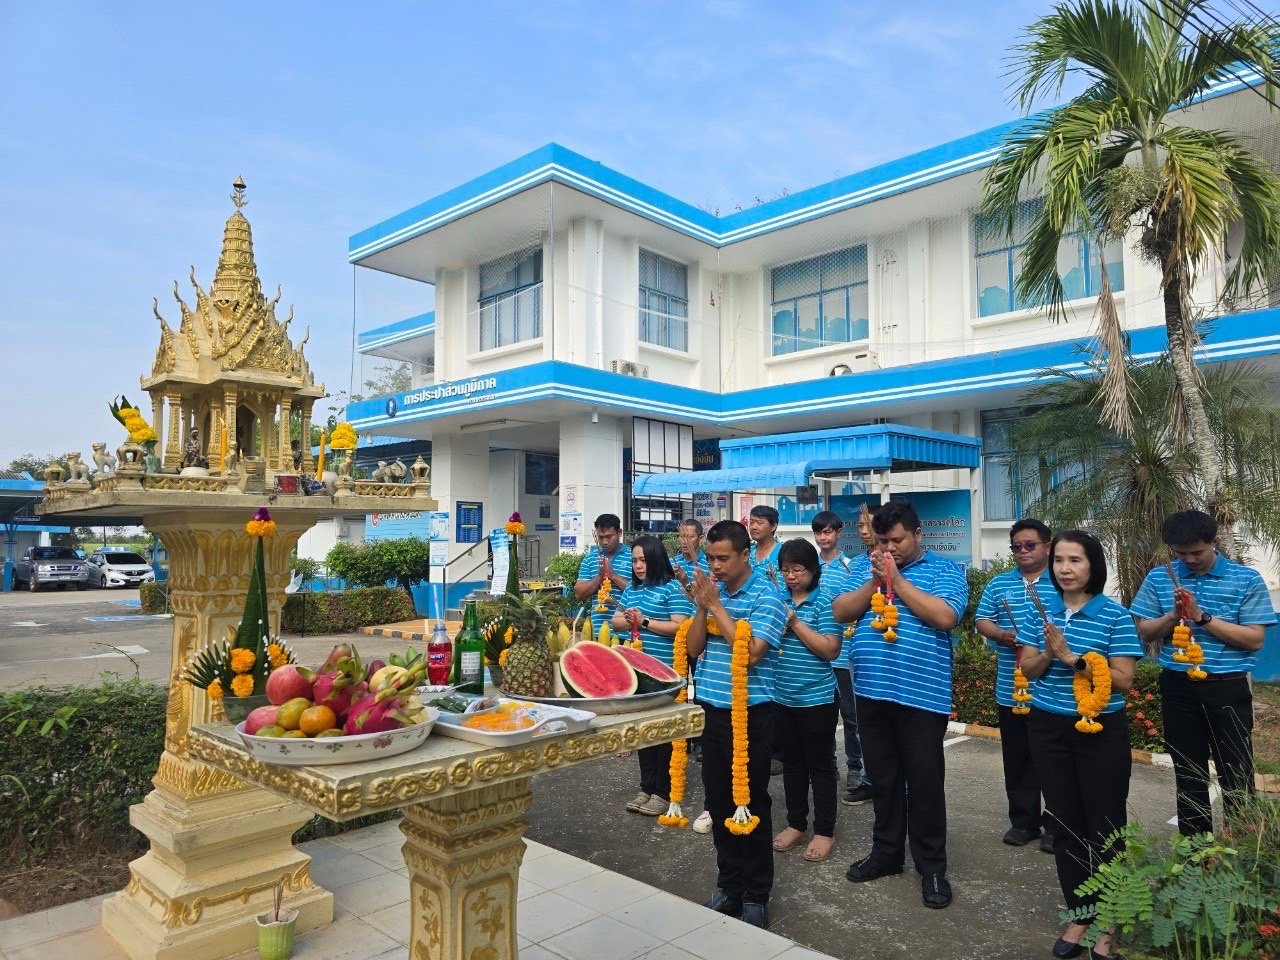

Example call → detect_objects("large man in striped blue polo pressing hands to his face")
832 499 969 909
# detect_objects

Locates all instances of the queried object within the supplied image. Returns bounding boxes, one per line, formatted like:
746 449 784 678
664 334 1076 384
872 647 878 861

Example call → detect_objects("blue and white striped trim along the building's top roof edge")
347 72 1262 262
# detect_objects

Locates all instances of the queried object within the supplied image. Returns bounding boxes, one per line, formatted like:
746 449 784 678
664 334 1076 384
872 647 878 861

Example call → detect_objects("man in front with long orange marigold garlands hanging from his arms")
689 520 787 928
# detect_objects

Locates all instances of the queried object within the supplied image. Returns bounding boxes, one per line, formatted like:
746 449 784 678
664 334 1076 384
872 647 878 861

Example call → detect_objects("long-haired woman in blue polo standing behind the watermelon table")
613 534 694 817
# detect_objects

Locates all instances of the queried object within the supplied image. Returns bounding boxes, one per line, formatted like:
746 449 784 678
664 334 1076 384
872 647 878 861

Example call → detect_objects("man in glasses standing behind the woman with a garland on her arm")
974 518 1057 854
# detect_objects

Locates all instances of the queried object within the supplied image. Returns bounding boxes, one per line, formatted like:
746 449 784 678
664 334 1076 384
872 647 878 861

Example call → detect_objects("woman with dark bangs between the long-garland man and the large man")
773 540 842 863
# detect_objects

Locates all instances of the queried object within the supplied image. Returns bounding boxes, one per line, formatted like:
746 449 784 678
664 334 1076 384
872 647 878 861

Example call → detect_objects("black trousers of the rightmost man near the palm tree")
1160 669 1253 837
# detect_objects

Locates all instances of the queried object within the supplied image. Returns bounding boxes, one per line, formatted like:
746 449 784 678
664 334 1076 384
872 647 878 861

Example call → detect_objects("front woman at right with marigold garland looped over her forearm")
1018 530 1142 960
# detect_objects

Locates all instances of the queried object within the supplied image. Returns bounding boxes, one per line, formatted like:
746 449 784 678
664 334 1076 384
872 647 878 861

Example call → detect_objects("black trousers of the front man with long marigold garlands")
703 703 776 904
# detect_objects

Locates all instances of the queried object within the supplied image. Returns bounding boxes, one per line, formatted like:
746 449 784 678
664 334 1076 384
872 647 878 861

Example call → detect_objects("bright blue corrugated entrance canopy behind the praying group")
631 424 982 497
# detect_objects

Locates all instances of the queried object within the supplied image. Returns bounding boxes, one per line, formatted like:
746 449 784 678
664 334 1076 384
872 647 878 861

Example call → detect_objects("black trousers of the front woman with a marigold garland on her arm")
1027 707 1133 910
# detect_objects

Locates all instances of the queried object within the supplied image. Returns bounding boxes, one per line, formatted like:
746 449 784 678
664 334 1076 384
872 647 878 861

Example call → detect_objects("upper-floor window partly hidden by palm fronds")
973 200 1124 316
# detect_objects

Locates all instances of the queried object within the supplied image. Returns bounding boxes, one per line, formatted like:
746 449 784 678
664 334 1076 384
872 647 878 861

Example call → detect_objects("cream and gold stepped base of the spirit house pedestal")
102 753 333 960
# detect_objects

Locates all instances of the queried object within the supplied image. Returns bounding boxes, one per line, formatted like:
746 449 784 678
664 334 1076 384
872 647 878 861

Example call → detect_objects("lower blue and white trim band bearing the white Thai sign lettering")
347 307 1280 430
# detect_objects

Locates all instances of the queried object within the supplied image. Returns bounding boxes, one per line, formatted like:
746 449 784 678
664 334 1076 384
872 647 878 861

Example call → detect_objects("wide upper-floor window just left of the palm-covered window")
772 246 870 356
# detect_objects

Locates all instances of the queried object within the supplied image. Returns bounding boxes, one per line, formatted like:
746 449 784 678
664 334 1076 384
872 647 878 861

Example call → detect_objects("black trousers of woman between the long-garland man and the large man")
773 701 840 837
